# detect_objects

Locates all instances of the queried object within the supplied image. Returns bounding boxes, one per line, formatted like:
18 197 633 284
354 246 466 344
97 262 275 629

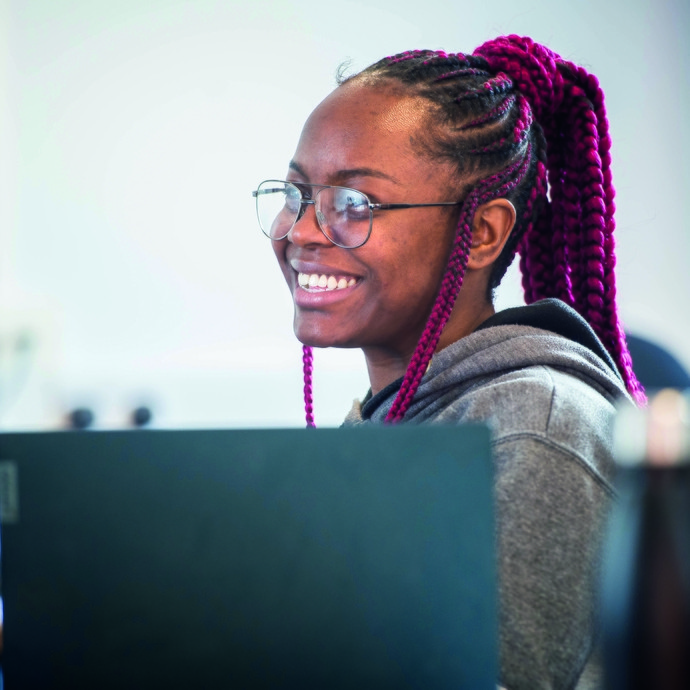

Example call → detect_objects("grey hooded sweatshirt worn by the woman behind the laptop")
345 325 627 690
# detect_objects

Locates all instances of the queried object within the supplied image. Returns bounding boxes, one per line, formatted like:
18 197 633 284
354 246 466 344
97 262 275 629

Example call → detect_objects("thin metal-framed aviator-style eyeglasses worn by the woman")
252 180 462 249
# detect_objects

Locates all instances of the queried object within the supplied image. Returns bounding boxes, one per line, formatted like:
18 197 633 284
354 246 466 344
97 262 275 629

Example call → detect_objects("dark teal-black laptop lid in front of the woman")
0 426 497 690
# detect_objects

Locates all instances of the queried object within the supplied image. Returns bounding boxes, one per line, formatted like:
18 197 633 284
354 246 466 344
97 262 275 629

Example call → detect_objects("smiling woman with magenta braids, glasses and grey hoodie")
255 36 644 689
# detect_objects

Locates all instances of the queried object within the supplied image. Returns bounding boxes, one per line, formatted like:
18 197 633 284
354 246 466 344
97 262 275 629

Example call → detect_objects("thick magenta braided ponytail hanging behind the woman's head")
475 36 646 404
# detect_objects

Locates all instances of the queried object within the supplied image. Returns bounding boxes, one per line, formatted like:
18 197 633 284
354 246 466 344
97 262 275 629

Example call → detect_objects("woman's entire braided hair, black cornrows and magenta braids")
304 36 645 425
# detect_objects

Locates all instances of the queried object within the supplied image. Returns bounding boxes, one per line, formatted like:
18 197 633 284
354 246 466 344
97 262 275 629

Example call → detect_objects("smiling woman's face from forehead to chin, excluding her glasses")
273 81 458 356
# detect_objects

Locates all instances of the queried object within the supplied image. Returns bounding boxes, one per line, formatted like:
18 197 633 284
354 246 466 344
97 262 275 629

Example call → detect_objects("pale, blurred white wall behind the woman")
0 0 690 429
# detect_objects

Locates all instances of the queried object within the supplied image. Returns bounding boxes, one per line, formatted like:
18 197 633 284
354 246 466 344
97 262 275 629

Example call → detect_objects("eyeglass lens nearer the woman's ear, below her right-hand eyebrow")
316 187 372 249
